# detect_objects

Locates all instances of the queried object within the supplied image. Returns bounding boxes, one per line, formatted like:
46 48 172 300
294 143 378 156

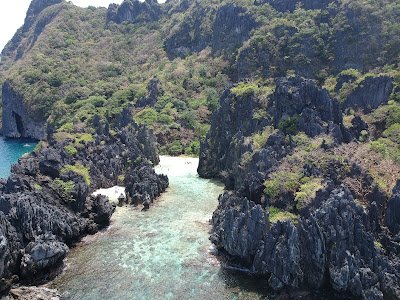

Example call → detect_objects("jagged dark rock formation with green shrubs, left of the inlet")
0 109 168 292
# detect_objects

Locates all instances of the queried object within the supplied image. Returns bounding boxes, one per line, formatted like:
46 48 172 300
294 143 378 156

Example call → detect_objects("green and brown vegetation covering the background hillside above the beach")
0 0 400 155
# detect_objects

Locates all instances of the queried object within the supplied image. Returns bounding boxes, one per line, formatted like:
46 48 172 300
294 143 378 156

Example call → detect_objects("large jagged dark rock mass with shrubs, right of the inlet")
198 77 400 299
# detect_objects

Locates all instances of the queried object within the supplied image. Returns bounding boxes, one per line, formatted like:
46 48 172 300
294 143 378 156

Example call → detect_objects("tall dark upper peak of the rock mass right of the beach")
198 77 347 188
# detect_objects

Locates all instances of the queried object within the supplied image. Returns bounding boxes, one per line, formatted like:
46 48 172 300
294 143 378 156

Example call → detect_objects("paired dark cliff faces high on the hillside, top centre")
164 4 257 58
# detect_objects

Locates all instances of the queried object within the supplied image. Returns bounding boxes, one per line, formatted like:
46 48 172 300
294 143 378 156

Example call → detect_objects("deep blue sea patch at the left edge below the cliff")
0 137 36 178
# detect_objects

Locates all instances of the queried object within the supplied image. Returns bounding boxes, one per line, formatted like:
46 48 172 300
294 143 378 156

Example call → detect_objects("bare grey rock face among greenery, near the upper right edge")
343 76 393 112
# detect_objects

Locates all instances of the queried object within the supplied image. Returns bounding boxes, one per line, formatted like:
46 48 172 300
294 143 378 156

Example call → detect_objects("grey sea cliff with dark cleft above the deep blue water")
2 81 46 140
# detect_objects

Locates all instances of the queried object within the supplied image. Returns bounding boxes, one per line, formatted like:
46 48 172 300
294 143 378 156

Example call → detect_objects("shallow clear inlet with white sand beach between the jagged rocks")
50 157 268 300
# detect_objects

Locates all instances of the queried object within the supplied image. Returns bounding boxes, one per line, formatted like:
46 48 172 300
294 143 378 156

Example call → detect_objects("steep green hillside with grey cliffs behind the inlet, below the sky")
1 0 400 154
